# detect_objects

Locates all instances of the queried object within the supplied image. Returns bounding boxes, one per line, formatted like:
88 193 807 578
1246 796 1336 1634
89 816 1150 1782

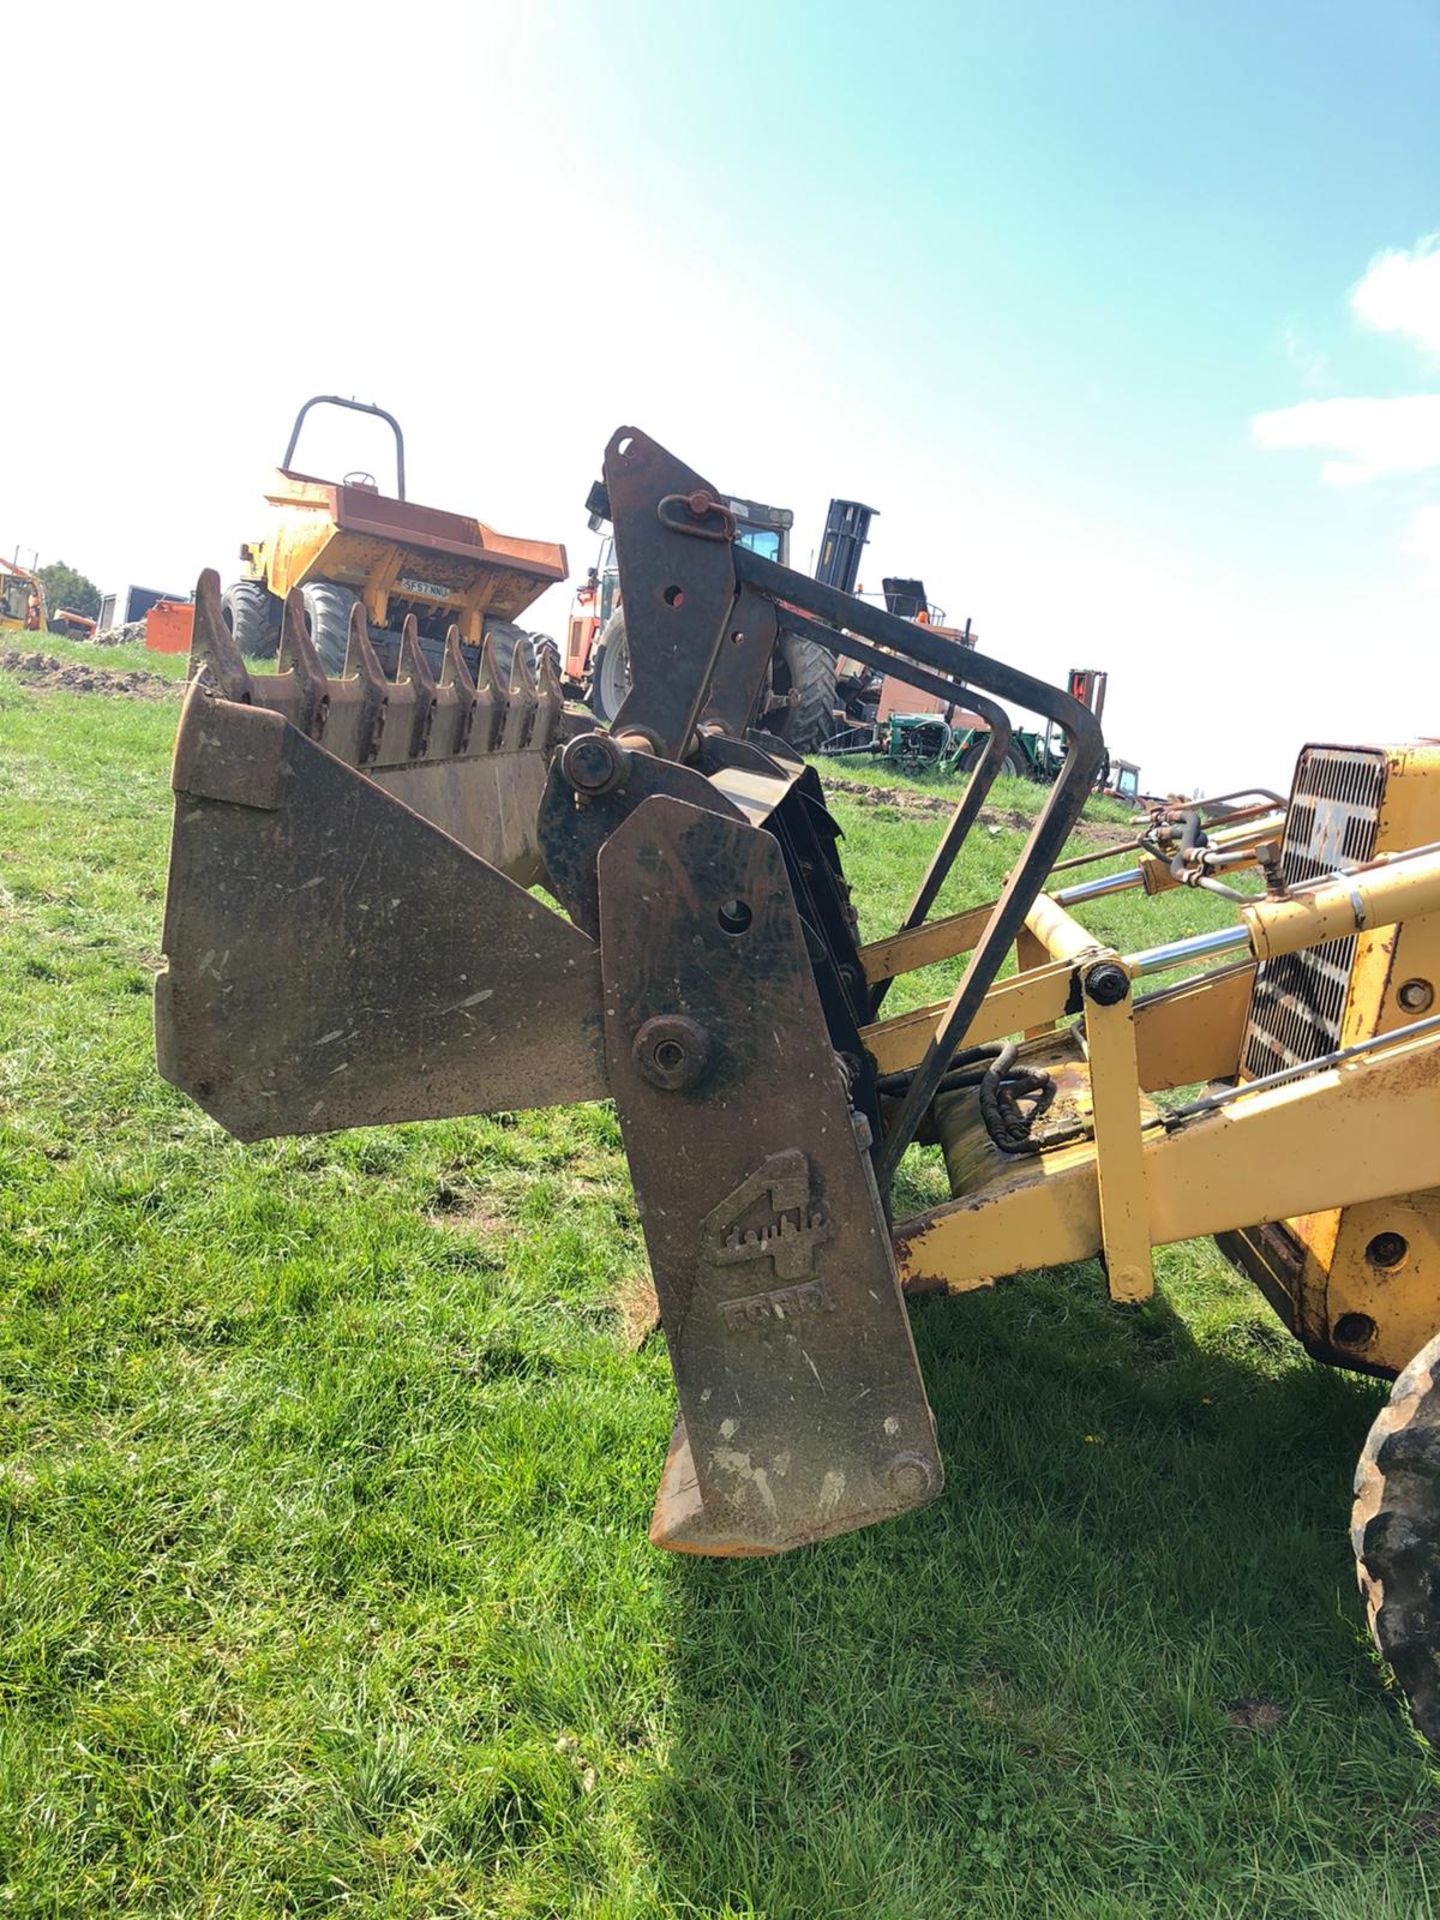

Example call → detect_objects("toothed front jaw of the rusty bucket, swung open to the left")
156 574 607 1139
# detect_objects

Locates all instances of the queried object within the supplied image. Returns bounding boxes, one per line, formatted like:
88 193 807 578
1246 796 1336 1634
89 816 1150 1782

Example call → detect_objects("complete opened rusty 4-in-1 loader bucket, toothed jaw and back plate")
156 428 971 1555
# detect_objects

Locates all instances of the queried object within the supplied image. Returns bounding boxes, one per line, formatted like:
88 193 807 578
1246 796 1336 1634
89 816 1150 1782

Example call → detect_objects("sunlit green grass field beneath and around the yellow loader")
0 639 1440 1920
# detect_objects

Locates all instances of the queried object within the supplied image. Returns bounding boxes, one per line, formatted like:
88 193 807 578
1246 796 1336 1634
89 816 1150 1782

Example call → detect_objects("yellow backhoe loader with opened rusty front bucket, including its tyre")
157 428 1440 1738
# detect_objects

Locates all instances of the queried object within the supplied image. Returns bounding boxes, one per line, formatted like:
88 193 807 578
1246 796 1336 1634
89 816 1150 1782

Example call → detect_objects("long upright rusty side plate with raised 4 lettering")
599 797 943 1553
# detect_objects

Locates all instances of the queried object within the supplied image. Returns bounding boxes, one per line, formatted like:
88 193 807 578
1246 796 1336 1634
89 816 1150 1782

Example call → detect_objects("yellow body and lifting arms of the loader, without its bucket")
864 743 1440 1373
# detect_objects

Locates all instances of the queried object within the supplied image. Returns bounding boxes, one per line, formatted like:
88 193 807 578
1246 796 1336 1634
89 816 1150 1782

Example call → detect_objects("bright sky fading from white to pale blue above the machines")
0 0 1440 791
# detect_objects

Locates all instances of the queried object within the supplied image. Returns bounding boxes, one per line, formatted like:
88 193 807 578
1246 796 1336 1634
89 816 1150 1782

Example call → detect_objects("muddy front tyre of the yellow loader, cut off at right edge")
1350 1334 1440 1747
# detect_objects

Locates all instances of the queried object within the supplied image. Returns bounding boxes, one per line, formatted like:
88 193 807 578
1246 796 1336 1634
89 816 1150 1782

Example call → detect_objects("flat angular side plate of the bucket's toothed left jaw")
156 685 609 1140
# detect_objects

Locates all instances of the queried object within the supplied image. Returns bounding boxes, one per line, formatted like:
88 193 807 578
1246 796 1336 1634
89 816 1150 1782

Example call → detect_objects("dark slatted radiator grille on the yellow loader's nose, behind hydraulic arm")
1242 747 1384 1079
